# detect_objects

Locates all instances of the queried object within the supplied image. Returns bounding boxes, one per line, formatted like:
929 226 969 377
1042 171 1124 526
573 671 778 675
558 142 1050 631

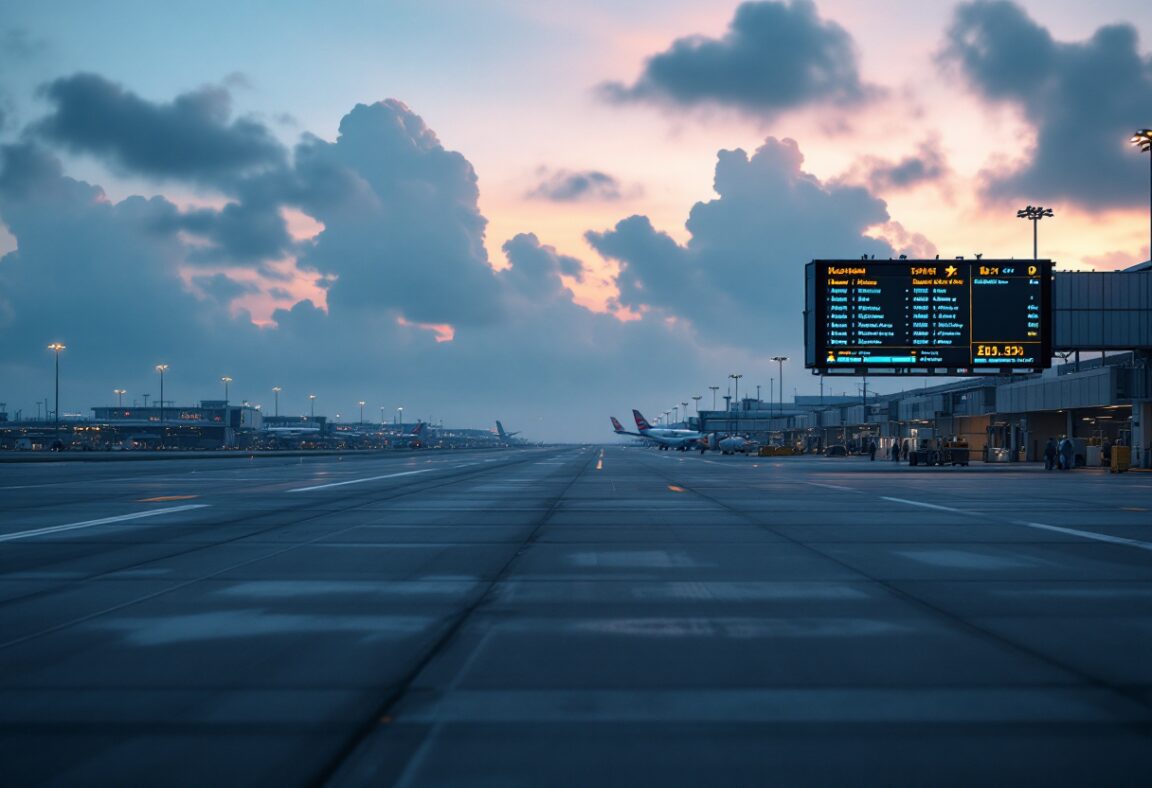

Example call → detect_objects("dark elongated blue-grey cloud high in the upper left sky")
35 74 285 183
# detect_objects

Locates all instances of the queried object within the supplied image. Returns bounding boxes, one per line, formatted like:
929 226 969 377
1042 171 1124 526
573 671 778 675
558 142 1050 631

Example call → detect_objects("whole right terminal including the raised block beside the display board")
690 263 1152 468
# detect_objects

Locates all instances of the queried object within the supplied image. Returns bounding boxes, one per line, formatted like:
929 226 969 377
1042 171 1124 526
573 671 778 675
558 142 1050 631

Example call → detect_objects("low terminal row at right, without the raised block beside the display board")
688 353 1152 468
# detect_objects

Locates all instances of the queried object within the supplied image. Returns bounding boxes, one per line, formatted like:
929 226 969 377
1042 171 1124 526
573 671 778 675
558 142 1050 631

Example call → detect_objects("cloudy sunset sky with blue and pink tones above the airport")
0 0 1152 441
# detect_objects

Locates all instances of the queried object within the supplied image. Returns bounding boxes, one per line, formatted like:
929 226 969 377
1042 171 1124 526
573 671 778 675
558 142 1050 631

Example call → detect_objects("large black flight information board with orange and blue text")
804 260 1052 374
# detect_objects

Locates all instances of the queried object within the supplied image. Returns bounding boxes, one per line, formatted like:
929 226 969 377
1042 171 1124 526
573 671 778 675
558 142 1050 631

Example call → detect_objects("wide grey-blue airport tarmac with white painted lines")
0 446 1152 786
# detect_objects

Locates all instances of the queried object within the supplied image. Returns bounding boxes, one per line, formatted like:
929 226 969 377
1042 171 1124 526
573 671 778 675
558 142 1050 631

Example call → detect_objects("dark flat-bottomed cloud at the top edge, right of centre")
600 0 877 116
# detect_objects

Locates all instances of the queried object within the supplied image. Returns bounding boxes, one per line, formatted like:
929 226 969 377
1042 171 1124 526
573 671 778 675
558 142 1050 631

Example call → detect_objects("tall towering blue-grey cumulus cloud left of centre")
296 99 501 325
